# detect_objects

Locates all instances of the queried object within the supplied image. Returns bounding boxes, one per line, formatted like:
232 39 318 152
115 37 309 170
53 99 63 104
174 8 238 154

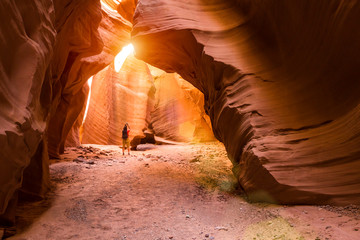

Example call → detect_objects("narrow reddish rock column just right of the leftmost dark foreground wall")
48 0 103 157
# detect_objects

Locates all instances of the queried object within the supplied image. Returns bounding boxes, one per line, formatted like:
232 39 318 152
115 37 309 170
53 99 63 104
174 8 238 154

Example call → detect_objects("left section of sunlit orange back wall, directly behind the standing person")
82 56 153 145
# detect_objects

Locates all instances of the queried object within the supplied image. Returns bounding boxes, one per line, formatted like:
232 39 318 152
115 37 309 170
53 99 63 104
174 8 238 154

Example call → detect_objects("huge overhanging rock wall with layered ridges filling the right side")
132 0 360 203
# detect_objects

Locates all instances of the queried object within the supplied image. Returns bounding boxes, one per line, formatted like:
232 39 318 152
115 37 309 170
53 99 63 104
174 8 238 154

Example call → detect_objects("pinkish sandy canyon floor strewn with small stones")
4 143 360 240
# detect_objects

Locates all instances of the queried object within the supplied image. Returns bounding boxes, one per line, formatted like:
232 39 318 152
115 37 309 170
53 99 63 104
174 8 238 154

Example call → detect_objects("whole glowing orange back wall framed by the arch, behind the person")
81 58 215 147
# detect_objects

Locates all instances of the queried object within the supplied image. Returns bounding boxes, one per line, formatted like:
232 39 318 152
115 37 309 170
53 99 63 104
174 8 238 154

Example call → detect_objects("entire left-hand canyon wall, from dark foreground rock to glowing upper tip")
0 0 135 225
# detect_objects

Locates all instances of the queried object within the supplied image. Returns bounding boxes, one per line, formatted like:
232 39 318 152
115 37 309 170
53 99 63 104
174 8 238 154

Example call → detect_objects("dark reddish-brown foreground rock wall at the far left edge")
0 0 56 220
